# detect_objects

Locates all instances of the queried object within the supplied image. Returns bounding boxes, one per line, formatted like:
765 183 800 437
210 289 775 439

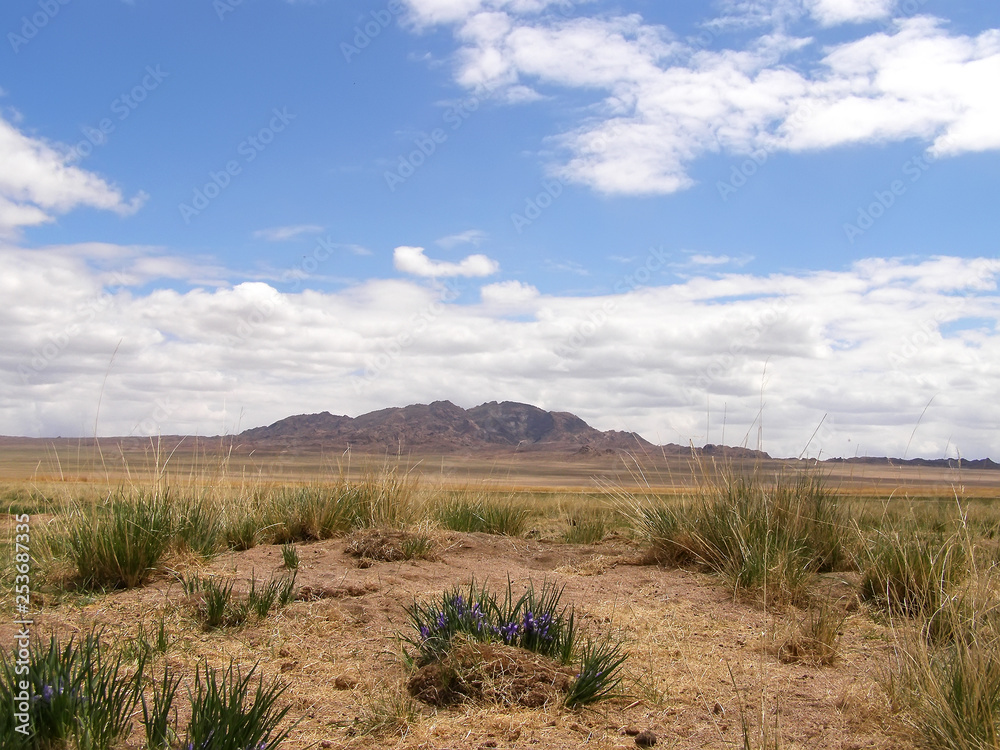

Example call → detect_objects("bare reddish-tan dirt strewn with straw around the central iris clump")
0 533 913 750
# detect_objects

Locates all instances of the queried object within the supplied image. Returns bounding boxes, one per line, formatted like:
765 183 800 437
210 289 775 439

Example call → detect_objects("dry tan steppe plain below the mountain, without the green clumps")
0 438 1000 750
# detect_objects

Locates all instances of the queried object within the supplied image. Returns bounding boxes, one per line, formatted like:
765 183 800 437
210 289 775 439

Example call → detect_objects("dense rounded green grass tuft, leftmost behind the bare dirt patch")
69 491 173 589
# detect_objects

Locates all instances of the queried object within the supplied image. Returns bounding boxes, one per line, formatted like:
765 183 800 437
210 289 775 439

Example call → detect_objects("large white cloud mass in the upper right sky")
409 0 1000 194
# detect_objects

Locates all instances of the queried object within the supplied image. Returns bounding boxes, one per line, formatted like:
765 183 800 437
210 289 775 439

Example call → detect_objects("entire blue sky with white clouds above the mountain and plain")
0 0 1000 457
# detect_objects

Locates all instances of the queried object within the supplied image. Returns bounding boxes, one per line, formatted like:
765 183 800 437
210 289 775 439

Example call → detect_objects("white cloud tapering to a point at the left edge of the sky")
0 116 147 236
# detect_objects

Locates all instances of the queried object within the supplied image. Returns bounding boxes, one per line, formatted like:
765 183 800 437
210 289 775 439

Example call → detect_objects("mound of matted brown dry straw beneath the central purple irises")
407 643 573 708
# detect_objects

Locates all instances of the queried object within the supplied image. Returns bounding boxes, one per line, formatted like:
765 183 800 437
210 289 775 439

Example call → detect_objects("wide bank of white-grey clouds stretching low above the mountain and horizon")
0 248 1000 458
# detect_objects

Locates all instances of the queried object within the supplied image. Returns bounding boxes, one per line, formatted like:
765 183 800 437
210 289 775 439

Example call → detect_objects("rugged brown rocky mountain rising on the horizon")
239 401 664 453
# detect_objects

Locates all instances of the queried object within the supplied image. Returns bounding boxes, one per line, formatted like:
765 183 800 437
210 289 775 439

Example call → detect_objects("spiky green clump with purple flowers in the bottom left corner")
0 632 146 750
